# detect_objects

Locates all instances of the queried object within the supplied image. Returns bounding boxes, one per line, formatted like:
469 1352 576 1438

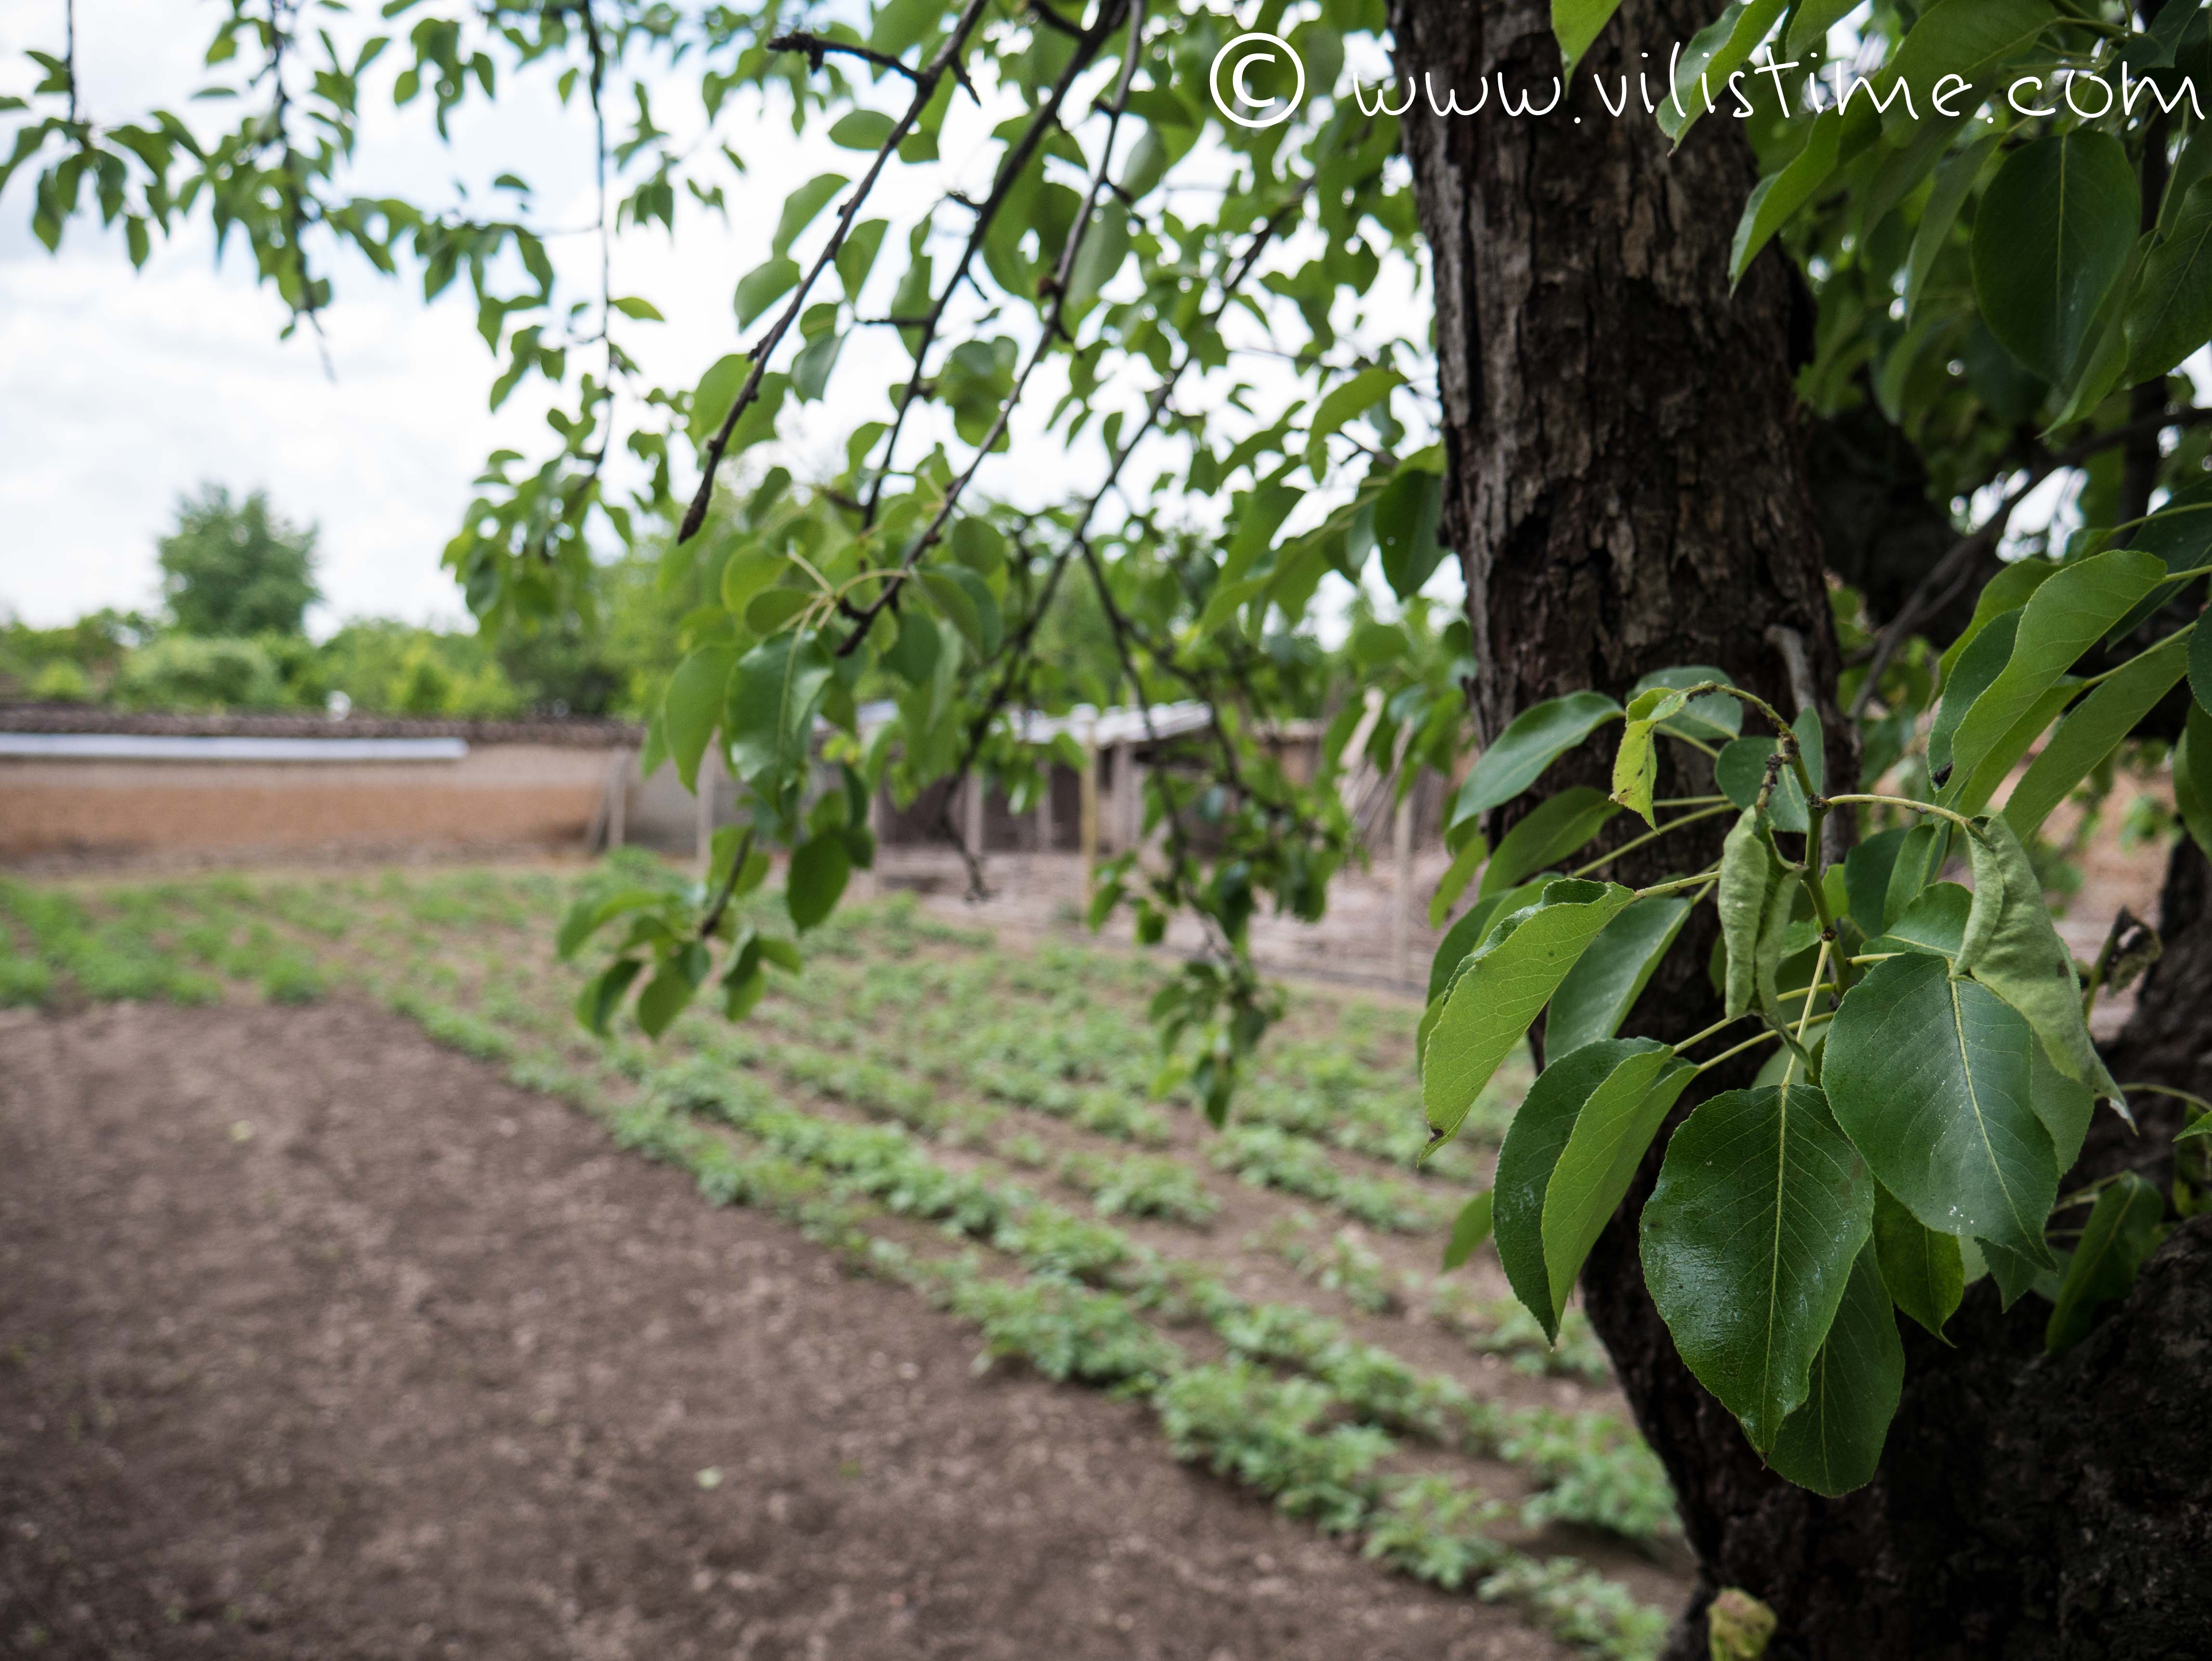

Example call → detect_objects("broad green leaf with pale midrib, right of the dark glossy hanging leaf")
1820 953 2059 1263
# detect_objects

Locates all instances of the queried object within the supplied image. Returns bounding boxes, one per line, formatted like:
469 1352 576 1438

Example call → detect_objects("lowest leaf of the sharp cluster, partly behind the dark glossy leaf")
1767 1243 1902 1500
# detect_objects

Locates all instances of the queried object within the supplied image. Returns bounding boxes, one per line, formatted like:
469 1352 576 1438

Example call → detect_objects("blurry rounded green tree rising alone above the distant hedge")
159 484 323 635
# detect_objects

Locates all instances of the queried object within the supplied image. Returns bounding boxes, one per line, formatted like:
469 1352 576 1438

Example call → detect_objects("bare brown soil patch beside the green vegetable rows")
0 1002 1562 1661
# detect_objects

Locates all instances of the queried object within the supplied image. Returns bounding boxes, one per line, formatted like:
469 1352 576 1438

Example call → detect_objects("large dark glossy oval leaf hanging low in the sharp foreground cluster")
1644 1084 1873 1453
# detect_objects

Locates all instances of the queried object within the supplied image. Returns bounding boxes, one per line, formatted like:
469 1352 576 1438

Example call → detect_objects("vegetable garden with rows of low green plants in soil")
0 871 1681 1657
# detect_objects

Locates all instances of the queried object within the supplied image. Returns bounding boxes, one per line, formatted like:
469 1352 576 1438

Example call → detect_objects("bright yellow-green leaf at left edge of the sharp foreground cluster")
1420 878 1634 1144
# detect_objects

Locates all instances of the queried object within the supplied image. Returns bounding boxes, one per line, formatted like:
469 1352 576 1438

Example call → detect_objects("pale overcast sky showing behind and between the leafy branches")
0 0 1456 633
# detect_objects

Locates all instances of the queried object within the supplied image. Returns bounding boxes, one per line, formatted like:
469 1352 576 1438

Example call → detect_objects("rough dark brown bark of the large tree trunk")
1391 0 2212 1661
